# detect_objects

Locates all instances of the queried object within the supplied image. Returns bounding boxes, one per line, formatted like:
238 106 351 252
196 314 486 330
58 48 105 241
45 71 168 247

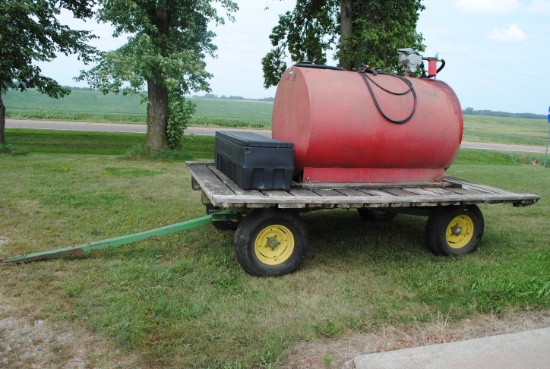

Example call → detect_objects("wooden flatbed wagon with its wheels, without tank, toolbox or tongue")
187 162 539 276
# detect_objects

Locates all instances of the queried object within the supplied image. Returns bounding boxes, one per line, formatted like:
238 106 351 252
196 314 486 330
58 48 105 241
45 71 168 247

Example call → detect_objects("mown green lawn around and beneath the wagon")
0 131 550 369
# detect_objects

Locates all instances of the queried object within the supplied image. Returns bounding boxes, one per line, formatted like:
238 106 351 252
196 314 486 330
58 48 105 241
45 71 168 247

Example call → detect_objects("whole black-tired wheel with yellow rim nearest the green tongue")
235 208 308 277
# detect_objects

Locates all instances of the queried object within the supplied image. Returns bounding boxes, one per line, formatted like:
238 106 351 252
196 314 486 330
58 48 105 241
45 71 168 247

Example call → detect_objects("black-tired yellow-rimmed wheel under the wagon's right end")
426 205 485 256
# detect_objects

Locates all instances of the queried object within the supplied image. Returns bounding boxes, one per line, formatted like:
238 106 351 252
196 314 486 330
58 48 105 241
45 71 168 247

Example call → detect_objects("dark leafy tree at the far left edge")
0 0 95 145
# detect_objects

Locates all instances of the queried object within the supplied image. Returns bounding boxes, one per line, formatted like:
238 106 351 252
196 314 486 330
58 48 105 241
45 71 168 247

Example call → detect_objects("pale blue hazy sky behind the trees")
40 0 550 114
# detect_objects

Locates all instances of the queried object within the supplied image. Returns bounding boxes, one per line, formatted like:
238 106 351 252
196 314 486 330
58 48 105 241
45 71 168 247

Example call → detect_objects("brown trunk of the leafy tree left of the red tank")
147 80 168 151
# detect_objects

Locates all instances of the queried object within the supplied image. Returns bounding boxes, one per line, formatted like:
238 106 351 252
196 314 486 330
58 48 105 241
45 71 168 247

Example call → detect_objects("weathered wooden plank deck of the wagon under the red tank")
187 162 539 209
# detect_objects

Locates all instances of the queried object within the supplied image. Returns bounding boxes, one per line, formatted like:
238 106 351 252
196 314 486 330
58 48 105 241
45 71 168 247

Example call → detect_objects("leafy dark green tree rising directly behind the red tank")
262 0 424 88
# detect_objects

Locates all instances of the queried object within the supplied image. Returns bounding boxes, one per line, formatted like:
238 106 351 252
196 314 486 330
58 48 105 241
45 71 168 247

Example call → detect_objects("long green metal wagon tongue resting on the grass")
0 210 237 264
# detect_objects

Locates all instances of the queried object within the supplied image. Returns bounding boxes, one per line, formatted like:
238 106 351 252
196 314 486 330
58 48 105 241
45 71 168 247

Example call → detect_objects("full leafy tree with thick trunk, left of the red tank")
79 0 237 151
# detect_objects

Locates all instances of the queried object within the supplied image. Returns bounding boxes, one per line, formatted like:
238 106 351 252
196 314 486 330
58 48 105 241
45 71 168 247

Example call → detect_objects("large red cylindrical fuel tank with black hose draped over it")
272 66 463 183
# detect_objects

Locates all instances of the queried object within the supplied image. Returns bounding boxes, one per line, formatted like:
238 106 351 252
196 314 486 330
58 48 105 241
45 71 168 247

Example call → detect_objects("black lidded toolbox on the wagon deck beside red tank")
214 131 294 190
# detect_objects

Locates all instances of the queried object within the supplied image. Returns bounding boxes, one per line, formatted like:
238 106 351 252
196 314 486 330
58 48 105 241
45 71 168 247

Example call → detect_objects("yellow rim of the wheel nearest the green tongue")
254 225 294 265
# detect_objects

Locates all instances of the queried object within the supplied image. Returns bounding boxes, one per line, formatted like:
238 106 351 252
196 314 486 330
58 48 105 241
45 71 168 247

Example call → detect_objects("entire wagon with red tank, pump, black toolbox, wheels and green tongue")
0 57 539 276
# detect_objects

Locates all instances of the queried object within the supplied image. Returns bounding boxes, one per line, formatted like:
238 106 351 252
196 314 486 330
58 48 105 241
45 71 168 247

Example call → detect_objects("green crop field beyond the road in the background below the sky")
4 90 548 146
